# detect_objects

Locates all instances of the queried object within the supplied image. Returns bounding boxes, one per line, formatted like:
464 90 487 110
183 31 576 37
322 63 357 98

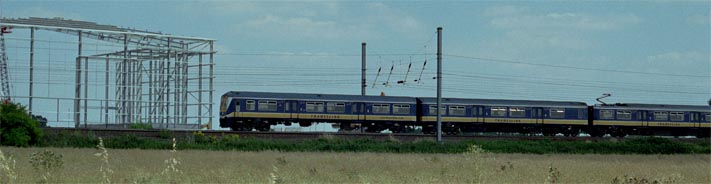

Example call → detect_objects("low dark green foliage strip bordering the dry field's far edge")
41 131 711 154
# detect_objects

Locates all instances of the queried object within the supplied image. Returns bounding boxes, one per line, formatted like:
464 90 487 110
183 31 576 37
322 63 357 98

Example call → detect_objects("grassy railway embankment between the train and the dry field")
39 128 711 154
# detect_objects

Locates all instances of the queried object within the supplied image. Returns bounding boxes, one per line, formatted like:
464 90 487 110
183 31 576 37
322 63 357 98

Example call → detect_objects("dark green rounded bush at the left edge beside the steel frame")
0 102 42 146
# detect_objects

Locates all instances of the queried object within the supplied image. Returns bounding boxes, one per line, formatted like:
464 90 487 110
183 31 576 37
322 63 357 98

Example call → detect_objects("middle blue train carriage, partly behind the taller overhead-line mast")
418 98 588 136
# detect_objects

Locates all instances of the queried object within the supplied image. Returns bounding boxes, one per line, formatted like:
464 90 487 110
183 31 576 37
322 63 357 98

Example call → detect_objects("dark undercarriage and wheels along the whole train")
220 118 711 137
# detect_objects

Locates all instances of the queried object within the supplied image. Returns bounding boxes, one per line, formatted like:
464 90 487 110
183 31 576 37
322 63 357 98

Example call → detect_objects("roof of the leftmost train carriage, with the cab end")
223 91 417 104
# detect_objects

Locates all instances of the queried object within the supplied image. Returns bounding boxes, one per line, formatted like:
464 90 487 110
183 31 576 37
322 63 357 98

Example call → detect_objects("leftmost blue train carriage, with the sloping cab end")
220 92 416 132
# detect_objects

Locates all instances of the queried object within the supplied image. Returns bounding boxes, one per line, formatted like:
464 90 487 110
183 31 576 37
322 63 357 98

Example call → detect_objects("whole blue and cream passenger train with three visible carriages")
220 91 711 137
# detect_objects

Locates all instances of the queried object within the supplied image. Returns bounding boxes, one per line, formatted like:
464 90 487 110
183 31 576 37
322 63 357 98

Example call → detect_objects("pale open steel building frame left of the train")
0 18 215 128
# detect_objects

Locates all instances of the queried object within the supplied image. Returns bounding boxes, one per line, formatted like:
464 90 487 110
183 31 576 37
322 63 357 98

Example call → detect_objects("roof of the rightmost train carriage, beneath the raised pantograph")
595 103 711 112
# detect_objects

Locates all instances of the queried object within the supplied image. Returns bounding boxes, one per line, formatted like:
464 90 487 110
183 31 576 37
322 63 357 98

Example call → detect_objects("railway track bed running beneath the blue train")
43 128 709 142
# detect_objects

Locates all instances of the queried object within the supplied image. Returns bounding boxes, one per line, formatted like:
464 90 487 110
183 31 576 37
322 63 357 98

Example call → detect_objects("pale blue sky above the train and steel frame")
0 0 711 128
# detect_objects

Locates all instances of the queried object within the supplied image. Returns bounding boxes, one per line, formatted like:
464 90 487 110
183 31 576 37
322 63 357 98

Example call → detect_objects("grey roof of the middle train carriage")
420 97 587 108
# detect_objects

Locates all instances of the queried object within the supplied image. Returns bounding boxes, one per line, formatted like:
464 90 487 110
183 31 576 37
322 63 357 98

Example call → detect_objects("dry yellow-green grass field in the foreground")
0 147 711 183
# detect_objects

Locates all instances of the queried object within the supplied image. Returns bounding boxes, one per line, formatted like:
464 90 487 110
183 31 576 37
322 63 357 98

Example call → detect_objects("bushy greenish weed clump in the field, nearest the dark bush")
30 150 64 183
